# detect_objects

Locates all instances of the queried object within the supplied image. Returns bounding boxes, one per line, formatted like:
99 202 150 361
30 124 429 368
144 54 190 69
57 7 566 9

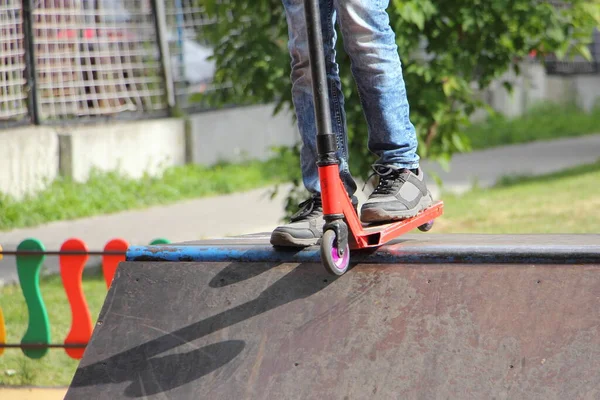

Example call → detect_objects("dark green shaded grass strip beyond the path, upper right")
465 104 600 150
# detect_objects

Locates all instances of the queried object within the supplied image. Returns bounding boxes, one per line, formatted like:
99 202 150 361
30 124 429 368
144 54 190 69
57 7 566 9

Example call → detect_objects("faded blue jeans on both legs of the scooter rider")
282 0 419 195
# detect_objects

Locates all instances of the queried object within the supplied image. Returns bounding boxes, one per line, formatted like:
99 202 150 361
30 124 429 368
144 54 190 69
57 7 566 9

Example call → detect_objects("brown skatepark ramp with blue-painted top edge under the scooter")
66 234 600 400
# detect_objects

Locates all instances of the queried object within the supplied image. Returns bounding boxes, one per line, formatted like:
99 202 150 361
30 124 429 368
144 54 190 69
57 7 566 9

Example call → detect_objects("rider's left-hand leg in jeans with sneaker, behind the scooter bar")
271 0 356 246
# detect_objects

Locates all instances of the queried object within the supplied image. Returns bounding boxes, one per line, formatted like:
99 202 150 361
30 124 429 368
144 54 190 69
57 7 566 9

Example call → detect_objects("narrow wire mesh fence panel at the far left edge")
0 0 28 121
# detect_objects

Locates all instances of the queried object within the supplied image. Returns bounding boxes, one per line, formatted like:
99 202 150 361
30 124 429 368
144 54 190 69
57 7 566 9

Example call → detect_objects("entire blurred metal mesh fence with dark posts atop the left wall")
0 0 223 126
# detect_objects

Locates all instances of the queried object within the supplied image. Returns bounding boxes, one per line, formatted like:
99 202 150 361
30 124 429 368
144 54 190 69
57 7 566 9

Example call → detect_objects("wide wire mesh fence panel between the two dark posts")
32 0 166 120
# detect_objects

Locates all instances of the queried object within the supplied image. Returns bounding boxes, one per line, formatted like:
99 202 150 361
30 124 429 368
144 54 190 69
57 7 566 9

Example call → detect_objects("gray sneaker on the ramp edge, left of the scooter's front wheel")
271 195 325 247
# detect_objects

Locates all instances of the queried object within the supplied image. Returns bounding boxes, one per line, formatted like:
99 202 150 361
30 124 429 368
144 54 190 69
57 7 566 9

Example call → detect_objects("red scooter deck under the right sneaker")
349 201 444 249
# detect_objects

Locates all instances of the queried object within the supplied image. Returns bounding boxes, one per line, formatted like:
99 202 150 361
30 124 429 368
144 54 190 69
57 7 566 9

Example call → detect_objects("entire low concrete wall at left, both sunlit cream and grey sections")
0 106 299 199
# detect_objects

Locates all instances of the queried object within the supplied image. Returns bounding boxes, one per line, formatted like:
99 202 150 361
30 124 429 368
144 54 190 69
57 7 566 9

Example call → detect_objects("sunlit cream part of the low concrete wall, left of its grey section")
0 119 185 199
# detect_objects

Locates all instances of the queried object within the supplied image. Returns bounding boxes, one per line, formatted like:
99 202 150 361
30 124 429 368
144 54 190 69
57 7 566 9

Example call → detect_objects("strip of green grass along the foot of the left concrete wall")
0 153 298 234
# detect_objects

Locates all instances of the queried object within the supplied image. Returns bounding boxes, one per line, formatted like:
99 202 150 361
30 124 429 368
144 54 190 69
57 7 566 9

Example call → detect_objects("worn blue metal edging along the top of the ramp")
126 245 600 264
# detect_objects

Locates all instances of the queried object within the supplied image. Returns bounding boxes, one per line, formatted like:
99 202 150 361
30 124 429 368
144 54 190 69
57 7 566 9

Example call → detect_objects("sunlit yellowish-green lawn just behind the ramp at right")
434 161 600 234
